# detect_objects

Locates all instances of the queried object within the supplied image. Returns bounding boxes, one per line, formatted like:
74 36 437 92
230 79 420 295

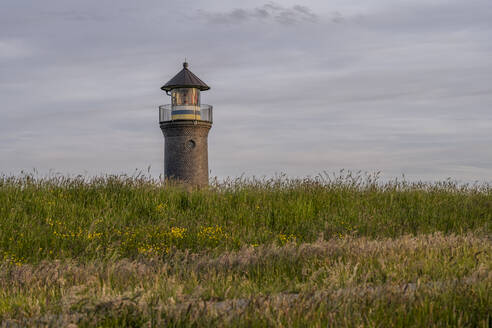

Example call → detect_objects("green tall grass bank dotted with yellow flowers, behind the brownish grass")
0 172 492 264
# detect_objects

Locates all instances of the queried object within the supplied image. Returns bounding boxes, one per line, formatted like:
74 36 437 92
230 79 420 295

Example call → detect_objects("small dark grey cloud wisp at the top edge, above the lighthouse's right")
198 2 318 25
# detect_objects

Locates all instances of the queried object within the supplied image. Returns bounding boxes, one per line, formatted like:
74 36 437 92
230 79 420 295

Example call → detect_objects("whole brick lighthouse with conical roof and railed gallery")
159 62 212 187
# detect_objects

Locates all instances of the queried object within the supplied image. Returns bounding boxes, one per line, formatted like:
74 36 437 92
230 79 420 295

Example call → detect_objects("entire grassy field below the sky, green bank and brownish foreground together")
0 172 492 327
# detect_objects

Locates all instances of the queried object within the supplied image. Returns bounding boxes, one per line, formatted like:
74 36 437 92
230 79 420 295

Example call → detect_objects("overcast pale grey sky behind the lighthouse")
0 0 492 182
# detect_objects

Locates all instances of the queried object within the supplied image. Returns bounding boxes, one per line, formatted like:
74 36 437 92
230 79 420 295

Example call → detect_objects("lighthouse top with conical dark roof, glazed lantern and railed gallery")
159 62 212 122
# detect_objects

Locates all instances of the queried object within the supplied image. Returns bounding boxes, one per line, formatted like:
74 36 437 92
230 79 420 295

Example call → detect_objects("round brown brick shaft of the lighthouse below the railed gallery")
161 121 212 186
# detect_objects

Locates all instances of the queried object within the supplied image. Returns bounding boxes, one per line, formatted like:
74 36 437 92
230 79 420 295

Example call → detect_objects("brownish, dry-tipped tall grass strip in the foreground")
0 233 492 328
